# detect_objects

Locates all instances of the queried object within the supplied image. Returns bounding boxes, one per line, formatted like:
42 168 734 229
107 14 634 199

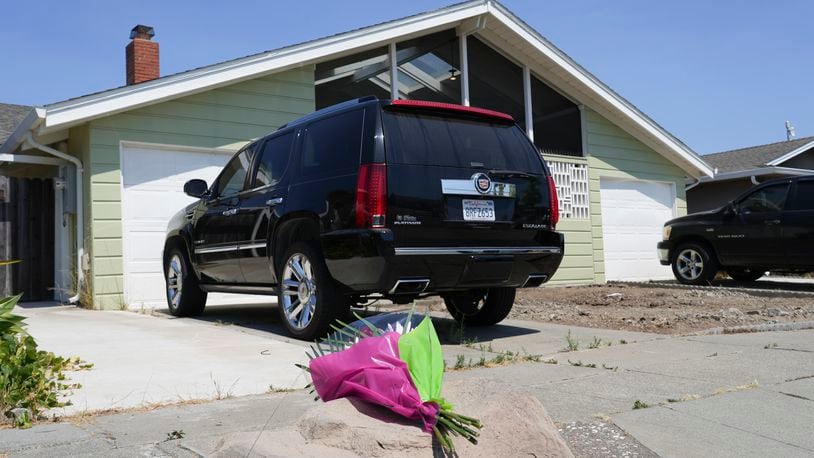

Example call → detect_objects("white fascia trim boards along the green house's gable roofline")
0 0 713 177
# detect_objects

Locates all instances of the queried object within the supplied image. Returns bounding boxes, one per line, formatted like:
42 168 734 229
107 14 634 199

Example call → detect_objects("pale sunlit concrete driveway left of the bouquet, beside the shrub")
17 303 308 415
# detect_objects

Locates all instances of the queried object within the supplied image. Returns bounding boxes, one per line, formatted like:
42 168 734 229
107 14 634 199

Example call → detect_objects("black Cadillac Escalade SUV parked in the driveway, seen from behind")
164 97 563 339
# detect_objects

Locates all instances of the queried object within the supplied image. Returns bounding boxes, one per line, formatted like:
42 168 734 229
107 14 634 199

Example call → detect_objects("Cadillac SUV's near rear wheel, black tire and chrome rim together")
277 242 349 340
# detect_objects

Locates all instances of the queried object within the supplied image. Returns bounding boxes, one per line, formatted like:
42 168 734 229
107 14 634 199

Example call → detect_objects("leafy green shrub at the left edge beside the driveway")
0 296 91 428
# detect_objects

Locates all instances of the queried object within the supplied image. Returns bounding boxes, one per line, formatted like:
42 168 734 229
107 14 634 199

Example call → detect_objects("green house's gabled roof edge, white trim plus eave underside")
0 0 712 177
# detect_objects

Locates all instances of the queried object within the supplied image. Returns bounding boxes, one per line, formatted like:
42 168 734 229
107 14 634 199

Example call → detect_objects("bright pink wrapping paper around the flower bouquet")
309 332 438 432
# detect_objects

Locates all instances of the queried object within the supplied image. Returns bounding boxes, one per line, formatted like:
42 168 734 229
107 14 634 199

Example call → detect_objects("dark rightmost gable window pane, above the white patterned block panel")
531 75 583 156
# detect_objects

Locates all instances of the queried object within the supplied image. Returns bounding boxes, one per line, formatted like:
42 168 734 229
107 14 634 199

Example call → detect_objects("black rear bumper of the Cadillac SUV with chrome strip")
322 229 564 294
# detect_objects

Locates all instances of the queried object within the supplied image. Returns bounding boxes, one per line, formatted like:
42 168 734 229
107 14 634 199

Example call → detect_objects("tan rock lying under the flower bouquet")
199 379 573 458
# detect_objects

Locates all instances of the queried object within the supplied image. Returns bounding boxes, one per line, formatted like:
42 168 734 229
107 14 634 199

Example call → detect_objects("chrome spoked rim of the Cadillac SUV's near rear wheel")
281 253 317 329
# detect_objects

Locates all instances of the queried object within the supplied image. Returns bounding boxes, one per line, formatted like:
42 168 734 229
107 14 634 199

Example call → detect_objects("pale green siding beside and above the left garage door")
80 67 314 309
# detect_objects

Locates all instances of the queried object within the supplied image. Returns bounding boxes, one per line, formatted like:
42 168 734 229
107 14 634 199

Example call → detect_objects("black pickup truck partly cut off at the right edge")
658 176 814 285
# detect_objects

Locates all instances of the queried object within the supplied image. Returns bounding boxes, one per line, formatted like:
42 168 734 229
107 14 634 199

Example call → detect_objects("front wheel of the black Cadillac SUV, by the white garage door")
164 248 206 316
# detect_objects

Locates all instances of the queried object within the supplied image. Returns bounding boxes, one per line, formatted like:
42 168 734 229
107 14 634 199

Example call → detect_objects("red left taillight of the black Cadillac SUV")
356 164 387 228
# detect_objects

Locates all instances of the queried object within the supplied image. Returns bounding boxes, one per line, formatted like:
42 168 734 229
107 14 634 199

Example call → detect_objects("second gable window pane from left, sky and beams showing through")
396 30 461 103
